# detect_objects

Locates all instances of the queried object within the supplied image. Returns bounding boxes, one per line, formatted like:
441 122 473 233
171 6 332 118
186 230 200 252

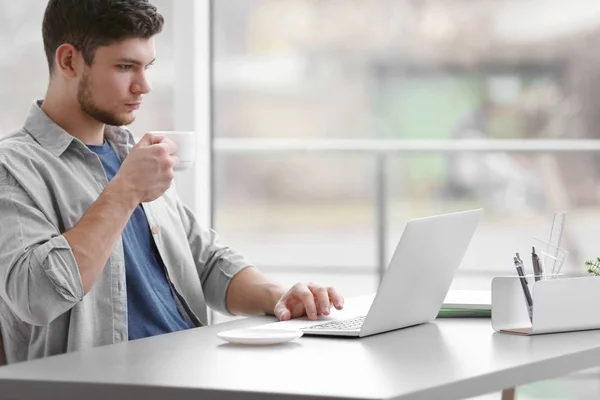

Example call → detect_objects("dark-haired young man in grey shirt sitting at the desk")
0 0 343 363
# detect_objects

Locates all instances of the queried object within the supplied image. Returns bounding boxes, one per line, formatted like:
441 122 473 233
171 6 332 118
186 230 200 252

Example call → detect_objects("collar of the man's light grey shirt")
24 100 135 157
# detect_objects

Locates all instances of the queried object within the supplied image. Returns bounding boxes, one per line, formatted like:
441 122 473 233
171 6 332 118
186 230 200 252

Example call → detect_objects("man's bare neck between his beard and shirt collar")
42 85 104 145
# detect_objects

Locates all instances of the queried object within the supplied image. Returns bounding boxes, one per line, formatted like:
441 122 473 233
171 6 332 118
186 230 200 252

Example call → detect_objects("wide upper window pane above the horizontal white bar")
213 0 600 139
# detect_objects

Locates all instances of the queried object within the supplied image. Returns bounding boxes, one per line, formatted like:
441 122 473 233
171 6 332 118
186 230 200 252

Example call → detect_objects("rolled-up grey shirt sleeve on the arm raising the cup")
0 170 83 326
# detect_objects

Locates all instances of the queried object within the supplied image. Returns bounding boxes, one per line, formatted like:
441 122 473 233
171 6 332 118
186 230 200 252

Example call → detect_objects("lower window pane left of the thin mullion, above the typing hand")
214 155 375 272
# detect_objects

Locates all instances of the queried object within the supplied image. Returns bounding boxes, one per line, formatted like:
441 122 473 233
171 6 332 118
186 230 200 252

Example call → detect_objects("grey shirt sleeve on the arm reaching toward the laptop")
172 192 252 315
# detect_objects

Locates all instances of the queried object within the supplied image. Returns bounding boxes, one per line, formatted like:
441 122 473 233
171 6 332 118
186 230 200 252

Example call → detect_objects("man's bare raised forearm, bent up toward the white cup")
63 180 137 294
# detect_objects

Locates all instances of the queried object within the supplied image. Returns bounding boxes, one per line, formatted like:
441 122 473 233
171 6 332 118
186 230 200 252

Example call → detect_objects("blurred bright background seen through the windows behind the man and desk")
0 0 600 398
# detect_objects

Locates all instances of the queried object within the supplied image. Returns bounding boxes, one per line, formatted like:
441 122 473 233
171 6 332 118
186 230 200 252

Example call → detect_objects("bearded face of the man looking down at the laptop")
77 38 155 126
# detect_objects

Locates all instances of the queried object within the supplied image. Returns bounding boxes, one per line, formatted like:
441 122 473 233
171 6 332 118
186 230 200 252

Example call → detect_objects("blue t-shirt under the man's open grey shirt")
88 141 190 340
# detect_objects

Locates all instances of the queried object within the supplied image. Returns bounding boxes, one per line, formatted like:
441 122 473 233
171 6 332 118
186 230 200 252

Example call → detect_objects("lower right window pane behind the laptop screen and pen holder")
387 153 600 289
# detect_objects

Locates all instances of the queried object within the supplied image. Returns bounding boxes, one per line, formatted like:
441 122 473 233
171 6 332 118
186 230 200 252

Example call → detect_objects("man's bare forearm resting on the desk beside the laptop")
226 267 286 315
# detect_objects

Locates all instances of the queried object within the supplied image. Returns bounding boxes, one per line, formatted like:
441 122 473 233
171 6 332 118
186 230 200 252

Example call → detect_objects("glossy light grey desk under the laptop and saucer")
0 296 600 400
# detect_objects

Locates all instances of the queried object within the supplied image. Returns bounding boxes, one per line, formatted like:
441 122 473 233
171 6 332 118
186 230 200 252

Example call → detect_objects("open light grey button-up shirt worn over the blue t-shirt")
0 101 250 363
